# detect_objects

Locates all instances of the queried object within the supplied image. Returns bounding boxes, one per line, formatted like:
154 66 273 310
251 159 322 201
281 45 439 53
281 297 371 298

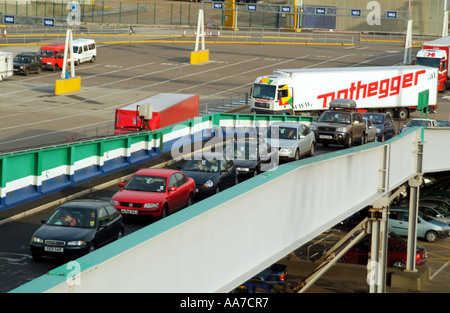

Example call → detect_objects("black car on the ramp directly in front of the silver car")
225 138 278 181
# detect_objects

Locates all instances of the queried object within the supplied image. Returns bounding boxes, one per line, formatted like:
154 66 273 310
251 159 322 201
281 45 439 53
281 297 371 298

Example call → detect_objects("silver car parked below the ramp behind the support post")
388 207 450 242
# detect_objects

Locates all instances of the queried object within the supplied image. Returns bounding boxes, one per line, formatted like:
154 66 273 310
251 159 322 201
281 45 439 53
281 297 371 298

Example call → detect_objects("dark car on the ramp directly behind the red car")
180 153 238 197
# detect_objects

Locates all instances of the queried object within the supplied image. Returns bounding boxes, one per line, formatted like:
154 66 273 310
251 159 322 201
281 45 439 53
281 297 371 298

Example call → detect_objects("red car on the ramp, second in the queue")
111 168 195 218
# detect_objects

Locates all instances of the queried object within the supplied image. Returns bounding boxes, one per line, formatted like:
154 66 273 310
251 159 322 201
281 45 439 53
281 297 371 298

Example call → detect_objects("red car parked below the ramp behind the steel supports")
339 235 427 269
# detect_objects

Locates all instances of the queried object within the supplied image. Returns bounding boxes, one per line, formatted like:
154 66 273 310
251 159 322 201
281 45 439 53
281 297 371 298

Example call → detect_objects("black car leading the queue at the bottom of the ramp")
30 200 124 260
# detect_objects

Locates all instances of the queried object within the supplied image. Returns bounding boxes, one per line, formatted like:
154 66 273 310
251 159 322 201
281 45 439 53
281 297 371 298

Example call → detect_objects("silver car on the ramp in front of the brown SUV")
266 122 316 160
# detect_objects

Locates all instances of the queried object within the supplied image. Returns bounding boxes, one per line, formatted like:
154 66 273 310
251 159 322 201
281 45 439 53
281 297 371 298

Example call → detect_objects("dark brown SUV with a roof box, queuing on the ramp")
310 99 367 148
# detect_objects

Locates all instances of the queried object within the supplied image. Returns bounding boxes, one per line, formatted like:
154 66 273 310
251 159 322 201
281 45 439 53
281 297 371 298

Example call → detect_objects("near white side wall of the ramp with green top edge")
7 113 450 293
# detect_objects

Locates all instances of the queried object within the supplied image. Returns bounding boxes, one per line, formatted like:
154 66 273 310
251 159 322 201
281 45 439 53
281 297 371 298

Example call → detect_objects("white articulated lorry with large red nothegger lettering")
250 65 438 118
